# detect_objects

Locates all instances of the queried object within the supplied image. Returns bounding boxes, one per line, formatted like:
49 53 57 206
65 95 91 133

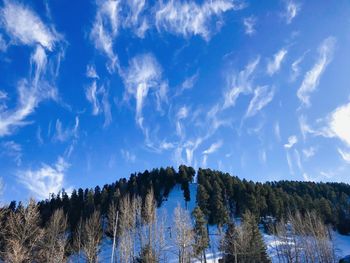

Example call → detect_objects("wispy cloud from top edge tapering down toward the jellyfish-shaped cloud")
90 0 120 71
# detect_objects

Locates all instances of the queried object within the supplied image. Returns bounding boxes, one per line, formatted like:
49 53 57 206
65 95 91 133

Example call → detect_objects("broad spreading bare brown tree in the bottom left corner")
5 199 43 263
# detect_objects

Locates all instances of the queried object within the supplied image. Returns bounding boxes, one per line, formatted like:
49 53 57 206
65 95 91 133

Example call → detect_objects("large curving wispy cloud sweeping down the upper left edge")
0 1 64 137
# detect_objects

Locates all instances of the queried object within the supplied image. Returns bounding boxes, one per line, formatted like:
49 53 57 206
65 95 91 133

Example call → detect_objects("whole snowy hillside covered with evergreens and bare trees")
0 165 350 262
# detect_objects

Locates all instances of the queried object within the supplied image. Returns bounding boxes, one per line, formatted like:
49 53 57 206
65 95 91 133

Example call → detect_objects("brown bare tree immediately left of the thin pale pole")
82 211 102 263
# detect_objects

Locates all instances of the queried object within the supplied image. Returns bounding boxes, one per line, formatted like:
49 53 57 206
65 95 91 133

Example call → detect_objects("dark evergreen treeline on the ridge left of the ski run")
4 165 196 236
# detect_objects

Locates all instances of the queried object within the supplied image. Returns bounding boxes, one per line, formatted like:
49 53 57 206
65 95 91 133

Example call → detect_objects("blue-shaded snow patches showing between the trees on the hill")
70 184 350 263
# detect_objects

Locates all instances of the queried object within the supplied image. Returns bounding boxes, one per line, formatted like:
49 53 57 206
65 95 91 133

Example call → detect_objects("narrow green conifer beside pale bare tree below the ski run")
192 206 209 263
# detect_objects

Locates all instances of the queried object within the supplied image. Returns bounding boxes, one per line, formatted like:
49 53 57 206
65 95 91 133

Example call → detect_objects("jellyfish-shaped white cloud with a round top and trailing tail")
123 54 167 128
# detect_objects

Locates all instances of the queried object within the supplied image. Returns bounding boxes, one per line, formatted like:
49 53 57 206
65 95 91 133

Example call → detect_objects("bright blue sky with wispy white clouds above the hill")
0 0 350 202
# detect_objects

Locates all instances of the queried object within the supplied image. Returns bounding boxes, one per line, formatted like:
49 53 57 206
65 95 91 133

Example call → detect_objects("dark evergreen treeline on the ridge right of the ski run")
197 169 350 234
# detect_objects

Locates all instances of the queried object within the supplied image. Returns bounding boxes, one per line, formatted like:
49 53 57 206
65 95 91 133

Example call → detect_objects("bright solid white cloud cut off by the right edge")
329 103 350 146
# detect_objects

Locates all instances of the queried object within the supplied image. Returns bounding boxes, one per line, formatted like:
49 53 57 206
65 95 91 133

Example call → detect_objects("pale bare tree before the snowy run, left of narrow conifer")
174 205 194 263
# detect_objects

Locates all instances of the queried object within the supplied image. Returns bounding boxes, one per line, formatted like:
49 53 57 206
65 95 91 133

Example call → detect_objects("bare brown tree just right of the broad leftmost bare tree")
41 209 68 263
